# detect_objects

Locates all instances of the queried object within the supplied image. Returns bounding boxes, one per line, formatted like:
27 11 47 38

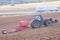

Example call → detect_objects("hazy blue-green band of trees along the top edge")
0 0 60 5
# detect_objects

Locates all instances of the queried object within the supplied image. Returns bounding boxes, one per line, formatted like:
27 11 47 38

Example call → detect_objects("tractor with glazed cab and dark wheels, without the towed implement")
31 15 58 28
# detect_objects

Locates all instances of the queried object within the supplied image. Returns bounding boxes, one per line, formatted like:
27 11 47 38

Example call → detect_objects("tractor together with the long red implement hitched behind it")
2 15 57 34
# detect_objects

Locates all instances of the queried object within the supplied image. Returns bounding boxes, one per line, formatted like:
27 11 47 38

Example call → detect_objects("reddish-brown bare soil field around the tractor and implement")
0 12 60 40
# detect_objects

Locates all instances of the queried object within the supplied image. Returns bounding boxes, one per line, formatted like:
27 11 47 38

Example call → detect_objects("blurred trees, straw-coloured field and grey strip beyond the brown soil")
0 0 60 15
